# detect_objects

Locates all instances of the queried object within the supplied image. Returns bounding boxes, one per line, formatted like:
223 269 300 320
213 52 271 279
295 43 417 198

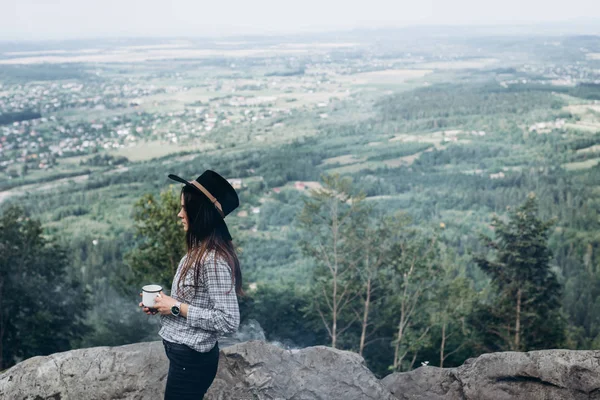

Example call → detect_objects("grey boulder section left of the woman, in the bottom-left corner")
0 342 169 400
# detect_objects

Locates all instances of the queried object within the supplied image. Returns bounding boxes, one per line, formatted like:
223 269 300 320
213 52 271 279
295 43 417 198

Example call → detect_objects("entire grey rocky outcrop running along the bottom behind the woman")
0 340 600 400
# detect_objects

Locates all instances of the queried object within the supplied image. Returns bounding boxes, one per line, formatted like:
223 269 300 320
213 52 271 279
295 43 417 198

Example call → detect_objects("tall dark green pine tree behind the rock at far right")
473 194 565 351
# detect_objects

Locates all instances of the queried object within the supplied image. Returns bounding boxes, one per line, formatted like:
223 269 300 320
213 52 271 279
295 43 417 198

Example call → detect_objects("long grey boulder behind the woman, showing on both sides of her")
0 340 394 400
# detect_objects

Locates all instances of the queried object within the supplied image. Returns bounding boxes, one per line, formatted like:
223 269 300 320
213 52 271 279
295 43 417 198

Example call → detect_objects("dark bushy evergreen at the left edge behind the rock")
0 206 89 370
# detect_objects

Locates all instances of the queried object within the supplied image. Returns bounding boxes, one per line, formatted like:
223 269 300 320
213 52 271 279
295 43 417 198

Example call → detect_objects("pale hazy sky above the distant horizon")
0 0 600 40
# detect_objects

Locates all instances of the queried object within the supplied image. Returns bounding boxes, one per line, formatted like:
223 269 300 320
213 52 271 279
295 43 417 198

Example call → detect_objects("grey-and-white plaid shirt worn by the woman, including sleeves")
158 251 240 352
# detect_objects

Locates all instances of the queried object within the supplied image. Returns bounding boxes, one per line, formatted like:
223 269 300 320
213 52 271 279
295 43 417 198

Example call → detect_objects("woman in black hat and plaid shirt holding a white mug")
140 170 244 400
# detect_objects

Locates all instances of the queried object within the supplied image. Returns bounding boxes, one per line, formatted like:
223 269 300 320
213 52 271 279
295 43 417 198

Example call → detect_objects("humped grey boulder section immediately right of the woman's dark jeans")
205 341 394 400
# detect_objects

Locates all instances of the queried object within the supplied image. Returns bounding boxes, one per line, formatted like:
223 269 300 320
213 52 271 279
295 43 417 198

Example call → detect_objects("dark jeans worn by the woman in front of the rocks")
163 339 219 400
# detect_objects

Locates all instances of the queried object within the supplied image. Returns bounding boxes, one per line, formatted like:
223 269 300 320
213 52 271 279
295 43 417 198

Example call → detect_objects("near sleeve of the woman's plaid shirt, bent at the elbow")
187 253 240 334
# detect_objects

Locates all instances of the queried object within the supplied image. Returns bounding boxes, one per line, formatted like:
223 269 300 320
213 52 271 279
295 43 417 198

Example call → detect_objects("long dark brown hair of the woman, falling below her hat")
177 185 245 296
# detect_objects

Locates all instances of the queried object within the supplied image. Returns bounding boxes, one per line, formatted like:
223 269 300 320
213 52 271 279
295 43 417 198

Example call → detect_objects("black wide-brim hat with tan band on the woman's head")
169 170 240 238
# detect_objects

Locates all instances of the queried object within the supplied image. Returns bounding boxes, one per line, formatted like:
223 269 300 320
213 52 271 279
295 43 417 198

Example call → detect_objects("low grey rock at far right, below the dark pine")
381 350 600 400
